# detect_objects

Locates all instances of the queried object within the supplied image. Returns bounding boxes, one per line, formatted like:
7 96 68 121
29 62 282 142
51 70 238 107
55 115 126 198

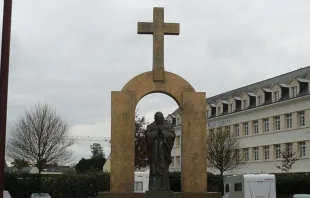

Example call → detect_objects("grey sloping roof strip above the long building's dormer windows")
207 66 310 104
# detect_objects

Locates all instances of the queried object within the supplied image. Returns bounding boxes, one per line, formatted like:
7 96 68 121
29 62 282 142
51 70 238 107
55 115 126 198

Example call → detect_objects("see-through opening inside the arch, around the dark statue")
134 93 181 191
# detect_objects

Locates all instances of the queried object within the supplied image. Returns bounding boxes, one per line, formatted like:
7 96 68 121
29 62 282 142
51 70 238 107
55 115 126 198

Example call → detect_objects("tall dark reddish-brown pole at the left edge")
0 0 12 198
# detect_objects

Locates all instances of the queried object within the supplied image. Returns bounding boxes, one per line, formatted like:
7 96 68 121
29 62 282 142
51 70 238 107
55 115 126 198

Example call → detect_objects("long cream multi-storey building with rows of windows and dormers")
167 66 310 174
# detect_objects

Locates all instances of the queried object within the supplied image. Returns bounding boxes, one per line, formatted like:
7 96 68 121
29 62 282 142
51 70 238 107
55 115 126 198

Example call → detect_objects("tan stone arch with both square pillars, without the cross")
110 71 207 193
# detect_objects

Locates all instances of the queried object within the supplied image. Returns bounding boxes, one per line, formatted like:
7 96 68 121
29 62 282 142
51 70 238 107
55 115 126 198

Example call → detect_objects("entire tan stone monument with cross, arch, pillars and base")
99 8 221 198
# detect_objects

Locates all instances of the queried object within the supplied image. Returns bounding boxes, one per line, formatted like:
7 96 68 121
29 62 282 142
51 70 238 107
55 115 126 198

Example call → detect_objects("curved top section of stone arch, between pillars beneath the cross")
122 71 196 107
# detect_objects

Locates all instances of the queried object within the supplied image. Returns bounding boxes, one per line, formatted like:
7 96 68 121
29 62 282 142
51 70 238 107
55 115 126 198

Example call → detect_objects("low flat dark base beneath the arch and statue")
98 191 222 198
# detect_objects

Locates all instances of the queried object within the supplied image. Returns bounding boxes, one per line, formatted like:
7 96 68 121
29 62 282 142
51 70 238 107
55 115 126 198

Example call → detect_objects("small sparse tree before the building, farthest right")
276 145 299 172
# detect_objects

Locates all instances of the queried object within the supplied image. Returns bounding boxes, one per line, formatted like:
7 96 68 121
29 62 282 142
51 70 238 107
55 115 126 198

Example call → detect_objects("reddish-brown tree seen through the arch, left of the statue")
135 111 148 169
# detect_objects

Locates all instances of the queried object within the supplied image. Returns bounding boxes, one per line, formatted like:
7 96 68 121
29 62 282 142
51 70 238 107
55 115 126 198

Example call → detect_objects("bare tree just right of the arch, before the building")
206 128 246 179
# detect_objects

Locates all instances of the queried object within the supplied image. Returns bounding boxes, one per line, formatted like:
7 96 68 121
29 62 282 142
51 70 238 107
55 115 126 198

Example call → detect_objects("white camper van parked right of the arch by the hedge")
223 174 276 198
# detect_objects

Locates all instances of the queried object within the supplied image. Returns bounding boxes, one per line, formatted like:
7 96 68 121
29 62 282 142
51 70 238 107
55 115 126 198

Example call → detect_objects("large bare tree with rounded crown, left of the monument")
7 104 74 174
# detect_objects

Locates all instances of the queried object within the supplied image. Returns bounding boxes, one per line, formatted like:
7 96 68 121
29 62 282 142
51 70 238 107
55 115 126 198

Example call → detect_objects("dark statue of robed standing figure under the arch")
145 112 175 191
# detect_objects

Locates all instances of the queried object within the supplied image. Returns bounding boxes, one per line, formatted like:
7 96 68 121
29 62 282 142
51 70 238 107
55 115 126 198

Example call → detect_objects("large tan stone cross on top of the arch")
138 8 180 82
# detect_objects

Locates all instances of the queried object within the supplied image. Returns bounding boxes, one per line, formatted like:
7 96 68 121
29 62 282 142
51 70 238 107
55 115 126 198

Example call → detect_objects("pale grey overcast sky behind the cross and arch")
1 0 310 164
